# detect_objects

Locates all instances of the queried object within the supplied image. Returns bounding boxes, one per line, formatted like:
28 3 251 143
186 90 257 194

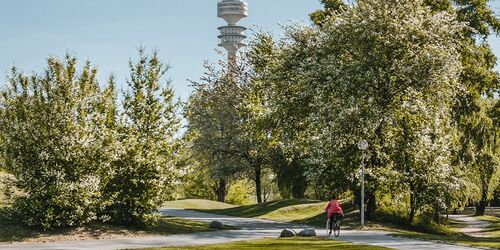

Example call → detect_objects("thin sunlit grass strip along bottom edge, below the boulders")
146 238 388 250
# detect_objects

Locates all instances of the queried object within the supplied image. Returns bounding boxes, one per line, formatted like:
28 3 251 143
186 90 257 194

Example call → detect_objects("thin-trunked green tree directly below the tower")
185 64 243 202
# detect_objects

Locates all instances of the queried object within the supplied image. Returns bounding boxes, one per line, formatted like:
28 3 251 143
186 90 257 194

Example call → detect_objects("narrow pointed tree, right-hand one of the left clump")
105 48 180 224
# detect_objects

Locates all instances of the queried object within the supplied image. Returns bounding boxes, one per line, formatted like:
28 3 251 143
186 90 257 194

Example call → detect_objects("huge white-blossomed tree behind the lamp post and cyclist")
258 0 464 222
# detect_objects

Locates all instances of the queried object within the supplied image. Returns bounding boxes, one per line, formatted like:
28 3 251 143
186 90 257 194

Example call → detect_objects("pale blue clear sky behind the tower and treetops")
0 0 500 98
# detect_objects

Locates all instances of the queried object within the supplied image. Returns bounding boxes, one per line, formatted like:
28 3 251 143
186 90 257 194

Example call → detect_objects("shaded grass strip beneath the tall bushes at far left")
0 209 234 243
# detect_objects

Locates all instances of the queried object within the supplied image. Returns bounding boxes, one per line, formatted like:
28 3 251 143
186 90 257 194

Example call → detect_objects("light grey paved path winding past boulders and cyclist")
0 209 480 250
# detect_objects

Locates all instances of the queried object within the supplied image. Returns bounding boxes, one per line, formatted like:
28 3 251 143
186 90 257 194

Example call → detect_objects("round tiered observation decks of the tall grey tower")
217 0 248 60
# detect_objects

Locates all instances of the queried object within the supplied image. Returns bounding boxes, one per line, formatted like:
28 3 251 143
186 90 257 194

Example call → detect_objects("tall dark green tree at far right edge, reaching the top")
418 0 500 214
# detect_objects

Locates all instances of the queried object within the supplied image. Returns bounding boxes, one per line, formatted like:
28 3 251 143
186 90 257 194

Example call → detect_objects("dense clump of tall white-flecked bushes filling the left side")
0 49 179 229
